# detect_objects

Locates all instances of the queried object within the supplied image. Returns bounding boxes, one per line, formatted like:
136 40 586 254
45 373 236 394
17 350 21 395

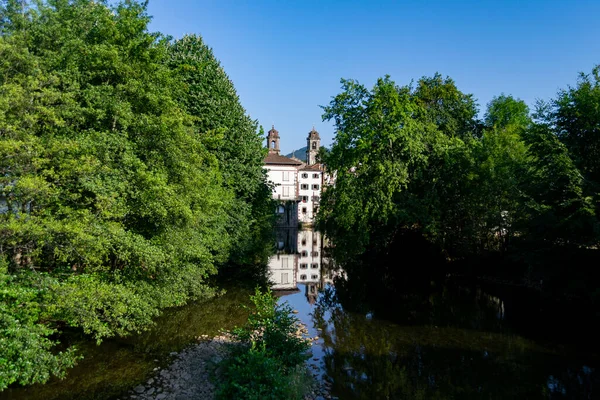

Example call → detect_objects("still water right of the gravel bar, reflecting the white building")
270 231 600 399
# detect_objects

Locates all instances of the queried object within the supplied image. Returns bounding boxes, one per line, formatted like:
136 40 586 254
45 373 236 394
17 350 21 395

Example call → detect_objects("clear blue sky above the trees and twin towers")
149 0 600 153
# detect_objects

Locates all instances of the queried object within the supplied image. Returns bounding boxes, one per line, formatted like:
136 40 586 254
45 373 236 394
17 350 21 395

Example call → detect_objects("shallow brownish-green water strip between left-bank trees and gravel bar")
0 288 251 400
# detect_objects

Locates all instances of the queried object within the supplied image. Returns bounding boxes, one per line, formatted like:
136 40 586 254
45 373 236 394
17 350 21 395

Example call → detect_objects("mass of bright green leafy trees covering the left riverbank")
0 0 271 390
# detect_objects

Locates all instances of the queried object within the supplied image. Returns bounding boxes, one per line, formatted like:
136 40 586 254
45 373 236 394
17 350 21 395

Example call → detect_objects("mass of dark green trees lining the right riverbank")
319 67 600 295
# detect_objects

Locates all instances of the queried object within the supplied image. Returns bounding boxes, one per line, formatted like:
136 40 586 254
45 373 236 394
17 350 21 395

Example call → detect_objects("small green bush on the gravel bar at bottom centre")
217 289 310 400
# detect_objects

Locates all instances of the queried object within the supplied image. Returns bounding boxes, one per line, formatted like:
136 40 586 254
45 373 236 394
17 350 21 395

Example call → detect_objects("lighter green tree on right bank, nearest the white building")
319 77 436 253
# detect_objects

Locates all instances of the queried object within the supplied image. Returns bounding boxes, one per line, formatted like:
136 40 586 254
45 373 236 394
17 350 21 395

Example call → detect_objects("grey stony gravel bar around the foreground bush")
120 335 335 400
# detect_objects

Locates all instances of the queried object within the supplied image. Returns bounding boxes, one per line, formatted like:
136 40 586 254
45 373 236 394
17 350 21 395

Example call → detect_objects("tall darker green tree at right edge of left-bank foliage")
168 35 274 263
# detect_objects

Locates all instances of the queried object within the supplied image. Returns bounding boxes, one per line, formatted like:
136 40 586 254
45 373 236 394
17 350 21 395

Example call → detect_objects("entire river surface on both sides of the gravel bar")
5 229 600 400
